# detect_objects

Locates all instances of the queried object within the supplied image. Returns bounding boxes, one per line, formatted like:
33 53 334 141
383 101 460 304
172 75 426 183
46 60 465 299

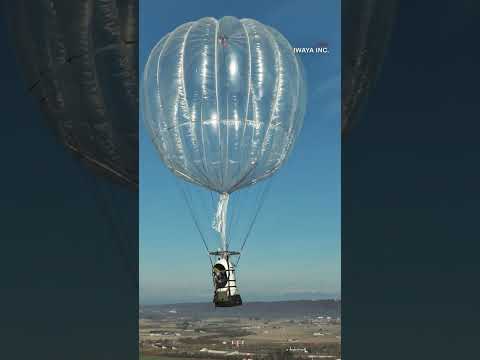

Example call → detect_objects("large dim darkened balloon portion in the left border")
8 0 138 189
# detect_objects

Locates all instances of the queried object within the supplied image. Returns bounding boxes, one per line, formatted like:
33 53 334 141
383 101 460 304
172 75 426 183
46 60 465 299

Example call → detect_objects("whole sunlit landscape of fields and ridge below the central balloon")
139 300 341 360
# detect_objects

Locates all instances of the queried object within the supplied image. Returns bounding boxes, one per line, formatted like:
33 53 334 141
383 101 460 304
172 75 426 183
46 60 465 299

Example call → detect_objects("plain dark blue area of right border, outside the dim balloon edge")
342 0 480 360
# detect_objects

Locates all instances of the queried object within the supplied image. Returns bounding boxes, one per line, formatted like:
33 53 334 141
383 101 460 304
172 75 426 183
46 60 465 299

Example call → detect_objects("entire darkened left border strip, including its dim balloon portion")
0 0 138 360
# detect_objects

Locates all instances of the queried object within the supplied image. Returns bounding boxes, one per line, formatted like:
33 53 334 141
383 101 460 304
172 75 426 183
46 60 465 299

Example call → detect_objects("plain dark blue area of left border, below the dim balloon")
0 1 139 360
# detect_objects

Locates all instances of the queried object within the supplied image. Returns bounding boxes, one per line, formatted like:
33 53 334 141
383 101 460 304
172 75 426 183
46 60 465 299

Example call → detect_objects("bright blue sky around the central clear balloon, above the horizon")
139 0 341 304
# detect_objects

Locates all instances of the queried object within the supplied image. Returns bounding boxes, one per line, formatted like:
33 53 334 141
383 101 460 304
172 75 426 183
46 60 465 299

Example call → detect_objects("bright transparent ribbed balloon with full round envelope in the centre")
142 16 306 197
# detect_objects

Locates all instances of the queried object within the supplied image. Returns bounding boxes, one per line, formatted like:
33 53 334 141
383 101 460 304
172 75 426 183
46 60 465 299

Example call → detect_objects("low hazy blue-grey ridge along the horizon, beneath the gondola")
140 300 341 319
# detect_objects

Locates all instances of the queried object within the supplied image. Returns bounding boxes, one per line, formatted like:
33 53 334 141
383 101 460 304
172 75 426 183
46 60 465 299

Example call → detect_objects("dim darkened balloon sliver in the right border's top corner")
342 0 397 135
